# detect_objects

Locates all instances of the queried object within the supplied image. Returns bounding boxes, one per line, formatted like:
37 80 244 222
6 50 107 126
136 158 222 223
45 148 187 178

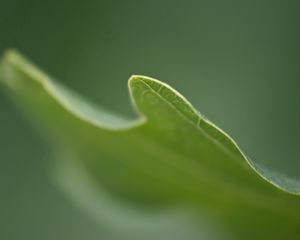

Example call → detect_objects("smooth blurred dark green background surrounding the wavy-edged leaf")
0 0 300 240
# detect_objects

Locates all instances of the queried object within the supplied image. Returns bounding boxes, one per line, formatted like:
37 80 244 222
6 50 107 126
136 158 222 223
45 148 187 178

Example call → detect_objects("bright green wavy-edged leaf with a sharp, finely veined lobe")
0 51 300 239
